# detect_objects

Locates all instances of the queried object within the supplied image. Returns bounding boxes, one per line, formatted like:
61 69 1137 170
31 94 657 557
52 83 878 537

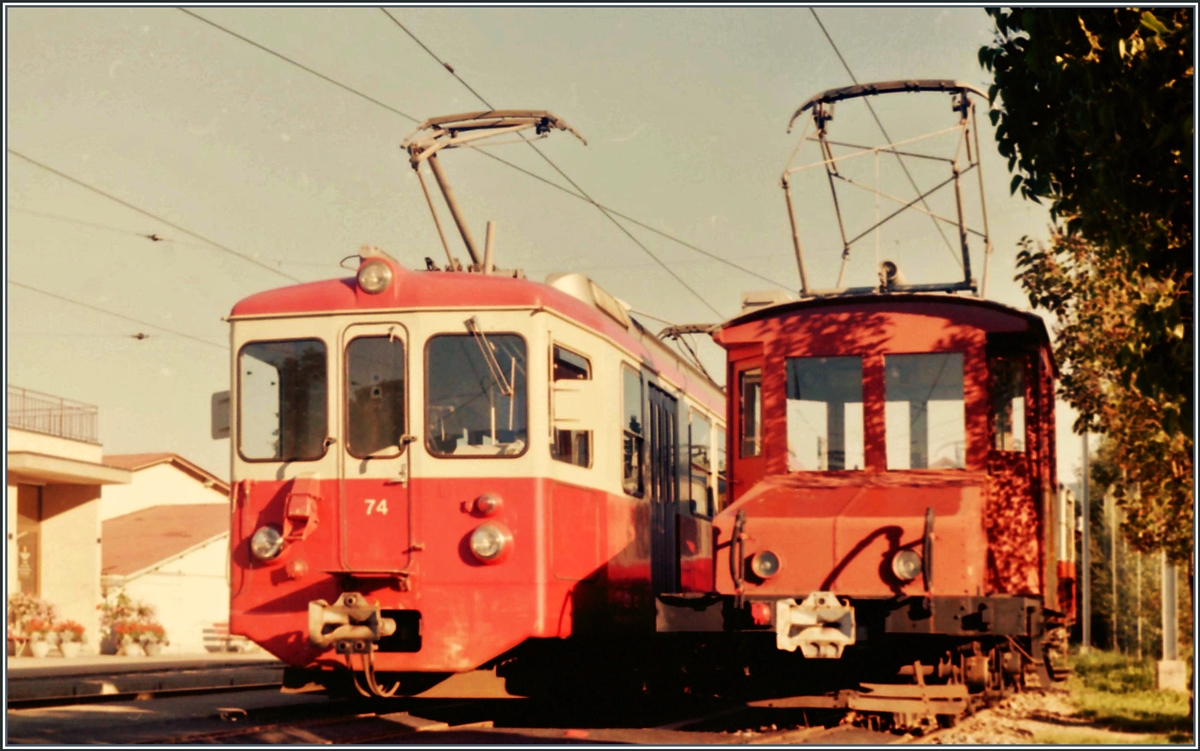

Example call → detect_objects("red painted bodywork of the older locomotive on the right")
714 295 1062 607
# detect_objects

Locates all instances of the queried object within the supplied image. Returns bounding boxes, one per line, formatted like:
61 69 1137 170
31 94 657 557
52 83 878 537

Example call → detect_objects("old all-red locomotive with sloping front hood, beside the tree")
660 293 1074 685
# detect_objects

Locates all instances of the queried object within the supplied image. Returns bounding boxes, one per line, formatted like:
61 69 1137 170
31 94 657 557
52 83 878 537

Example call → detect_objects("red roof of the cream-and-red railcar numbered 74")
228 258 725 415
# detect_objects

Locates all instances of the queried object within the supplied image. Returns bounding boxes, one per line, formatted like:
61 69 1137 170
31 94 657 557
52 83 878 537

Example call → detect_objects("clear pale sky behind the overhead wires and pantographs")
6 6 1079 481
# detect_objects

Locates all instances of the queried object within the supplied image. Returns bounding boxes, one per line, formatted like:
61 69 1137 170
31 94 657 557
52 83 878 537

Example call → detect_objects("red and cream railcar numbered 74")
229 250 725 693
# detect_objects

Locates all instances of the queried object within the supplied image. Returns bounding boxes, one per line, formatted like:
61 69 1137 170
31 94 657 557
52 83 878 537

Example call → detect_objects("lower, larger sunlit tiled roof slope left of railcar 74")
100 504 229 576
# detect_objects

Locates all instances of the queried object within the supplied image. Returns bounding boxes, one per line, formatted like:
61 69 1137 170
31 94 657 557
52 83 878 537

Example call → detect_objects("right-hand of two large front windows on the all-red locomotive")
883 353 966 469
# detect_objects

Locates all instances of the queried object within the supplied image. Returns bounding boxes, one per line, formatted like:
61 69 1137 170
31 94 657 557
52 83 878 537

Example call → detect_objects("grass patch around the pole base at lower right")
1067 650 1192 743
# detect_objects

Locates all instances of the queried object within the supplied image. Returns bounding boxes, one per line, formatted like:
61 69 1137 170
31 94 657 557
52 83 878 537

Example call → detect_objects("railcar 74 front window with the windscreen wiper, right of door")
425 329 529 457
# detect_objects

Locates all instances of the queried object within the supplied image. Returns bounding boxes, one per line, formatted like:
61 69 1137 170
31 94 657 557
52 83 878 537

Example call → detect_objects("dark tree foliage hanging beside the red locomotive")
979 7 1195 561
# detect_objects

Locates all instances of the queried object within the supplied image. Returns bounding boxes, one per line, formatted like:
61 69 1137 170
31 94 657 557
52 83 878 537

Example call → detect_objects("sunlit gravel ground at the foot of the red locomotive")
911 689 1150 745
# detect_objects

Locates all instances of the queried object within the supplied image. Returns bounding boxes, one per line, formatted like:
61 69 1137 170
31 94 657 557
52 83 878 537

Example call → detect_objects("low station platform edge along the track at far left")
6 653 283 703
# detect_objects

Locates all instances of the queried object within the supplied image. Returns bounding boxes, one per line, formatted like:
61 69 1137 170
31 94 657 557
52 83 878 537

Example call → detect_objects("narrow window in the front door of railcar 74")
346 336 404 458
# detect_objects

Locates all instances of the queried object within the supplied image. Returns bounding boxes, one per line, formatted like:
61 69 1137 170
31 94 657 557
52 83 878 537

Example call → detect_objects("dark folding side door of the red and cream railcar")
648 384 679 594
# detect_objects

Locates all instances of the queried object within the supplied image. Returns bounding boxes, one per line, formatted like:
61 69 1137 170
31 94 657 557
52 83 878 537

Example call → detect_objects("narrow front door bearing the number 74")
338 323 412 572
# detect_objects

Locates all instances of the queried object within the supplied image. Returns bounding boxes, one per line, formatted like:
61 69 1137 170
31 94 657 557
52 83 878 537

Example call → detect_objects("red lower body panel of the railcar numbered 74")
230 470 654 672
